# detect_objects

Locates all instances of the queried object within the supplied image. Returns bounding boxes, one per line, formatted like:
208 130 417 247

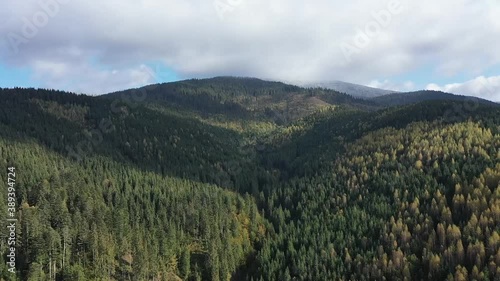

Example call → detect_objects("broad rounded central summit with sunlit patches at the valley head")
104 77 378 124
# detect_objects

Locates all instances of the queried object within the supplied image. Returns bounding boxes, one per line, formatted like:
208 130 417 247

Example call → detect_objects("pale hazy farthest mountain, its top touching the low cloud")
305 81 396 99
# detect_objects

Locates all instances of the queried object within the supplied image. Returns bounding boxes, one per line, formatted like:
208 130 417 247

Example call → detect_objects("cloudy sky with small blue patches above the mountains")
0 0 500 101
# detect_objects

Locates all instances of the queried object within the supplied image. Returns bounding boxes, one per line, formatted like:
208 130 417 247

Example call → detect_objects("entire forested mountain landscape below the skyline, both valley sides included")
0 77 500 280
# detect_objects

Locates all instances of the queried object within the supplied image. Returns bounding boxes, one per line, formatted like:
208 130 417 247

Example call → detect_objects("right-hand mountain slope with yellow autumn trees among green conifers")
257 101 500 280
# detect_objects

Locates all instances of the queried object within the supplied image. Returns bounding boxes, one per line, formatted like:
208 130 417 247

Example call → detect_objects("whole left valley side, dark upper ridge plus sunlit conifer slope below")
0 86 267 280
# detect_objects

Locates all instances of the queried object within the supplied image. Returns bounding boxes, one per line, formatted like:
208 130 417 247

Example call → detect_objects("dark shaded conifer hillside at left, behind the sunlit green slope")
0 89 259 189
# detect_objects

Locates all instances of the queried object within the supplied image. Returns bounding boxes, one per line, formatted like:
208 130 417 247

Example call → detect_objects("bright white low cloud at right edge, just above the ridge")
426 76 500 102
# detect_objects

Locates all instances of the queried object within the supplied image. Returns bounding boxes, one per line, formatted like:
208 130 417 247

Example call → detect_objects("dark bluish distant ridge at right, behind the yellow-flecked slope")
370 90 495 106
